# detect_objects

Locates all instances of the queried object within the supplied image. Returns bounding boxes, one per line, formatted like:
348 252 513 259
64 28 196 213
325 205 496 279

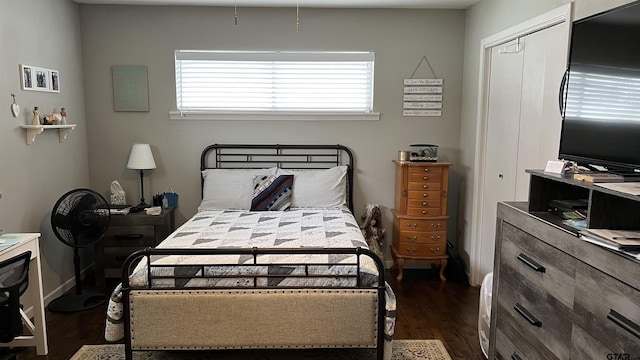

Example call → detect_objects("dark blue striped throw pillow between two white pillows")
251 175 293 211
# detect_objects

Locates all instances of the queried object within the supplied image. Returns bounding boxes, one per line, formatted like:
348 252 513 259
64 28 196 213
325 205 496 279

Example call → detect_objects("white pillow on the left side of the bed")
198 168 276 211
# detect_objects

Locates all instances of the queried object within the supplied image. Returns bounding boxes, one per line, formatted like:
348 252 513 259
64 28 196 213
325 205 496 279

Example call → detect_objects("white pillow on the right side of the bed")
277 166 347 208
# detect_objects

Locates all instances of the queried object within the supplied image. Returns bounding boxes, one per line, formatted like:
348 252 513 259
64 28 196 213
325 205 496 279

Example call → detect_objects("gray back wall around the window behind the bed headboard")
80 5 464 258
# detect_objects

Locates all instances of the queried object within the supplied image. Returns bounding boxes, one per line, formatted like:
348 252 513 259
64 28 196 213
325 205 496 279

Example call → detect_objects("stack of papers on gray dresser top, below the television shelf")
580 229 640 260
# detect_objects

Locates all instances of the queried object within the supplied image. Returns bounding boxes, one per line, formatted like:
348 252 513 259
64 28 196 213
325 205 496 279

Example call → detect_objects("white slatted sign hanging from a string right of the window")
402 56 444 116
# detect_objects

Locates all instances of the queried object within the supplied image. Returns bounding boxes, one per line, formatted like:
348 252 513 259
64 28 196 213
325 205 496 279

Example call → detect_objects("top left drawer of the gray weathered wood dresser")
500 222 576 308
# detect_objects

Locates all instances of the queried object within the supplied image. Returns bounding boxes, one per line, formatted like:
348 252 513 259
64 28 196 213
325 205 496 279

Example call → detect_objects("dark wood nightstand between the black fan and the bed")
95 209 175 282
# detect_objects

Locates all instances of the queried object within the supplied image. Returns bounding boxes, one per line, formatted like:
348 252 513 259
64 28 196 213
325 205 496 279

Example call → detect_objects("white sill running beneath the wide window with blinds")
169 111 380 121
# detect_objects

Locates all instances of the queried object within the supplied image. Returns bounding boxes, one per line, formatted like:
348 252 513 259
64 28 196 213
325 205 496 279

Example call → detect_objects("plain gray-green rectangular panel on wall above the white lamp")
112 66 149 111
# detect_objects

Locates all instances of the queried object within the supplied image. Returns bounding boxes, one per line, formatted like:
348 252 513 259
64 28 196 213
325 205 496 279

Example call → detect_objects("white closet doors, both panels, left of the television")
479 25 567 276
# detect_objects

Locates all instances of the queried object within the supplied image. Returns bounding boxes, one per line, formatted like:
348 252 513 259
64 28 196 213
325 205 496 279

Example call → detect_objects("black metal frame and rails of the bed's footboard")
122 247 386 360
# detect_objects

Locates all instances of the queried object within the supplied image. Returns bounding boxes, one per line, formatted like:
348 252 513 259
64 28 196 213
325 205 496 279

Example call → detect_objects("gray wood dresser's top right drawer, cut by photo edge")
573 263 640 356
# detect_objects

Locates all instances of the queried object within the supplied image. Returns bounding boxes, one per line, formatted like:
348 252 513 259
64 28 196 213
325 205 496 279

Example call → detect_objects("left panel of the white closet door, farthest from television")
480 41 523 273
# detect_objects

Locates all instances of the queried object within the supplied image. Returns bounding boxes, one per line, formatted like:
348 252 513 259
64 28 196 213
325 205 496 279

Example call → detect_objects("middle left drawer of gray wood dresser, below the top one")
497 268 572 359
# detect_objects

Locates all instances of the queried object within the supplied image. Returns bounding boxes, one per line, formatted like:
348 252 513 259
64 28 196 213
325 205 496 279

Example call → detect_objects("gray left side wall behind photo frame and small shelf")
0 0 92 306
